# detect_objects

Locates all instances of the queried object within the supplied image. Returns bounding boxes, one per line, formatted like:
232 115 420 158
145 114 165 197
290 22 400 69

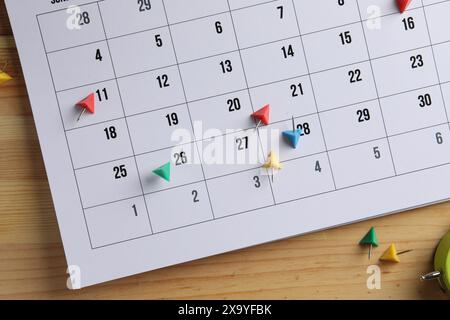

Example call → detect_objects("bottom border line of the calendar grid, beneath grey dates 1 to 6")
89 162 450 250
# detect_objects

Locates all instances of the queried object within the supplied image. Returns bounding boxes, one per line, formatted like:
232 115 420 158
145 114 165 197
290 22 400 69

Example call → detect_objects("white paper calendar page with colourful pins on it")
6 0 450 288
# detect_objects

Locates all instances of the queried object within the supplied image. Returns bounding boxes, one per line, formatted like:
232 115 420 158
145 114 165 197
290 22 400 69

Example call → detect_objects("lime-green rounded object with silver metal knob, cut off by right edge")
420 232 450 293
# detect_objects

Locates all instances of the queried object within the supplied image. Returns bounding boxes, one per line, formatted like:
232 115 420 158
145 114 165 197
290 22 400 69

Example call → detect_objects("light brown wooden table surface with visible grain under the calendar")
0 1 450 299
